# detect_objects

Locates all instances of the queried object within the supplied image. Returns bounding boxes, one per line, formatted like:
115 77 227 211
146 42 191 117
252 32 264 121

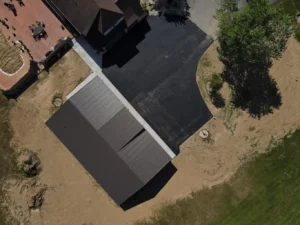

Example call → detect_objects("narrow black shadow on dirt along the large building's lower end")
120 162 177 211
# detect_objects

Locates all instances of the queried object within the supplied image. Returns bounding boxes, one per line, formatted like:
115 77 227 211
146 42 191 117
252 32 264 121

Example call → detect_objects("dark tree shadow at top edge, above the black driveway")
154 0 190 26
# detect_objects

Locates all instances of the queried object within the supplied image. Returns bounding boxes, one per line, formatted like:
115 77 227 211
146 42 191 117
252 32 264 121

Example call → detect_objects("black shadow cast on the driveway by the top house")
102 20 151 68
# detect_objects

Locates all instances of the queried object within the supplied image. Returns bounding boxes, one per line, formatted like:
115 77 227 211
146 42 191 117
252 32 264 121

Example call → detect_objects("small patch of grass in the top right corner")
275 0 300 41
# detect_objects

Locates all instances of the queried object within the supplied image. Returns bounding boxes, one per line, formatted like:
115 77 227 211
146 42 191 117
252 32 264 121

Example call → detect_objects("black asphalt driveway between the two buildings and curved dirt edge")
103 17 212 151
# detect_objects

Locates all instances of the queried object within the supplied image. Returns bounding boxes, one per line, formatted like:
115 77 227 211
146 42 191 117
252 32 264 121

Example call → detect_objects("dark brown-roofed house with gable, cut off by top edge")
44 0 147 53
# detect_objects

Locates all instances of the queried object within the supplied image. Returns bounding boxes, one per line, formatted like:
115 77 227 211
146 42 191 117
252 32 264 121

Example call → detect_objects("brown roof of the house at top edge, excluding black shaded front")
46 0 142 35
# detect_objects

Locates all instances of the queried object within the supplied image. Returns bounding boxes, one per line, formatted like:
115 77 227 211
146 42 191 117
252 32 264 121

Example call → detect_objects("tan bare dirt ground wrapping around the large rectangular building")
5 39 300 225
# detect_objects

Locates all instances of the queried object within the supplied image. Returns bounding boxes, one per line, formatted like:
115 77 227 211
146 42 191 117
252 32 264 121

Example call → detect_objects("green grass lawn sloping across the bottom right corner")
136 130 300 225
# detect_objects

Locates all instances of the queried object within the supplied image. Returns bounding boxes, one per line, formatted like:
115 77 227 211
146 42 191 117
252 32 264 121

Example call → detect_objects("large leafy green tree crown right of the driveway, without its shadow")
217 0 293 67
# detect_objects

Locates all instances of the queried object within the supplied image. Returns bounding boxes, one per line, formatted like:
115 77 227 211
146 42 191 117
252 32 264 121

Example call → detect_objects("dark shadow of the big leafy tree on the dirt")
222 61 282 119
